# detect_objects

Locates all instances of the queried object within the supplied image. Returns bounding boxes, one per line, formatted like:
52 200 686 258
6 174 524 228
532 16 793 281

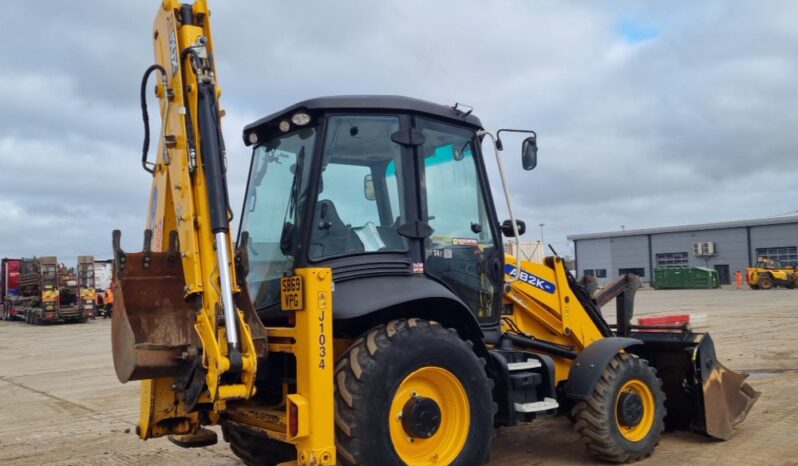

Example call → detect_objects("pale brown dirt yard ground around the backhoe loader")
0 288 798 466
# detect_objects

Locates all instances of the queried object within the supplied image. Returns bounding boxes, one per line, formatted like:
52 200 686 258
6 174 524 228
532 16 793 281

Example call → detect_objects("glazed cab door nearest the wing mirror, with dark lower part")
416 118 504 323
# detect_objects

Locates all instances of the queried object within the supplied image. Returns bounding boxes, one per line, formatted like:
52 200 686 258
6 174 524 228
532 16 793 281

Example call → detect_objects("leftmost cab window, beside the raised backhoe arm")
241 128 316 309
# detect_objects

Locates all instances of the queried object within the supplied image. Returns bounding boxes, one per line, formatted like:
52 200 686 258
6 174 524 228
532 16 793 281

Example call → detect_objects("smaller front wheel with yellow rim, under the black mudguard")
571 353 665 463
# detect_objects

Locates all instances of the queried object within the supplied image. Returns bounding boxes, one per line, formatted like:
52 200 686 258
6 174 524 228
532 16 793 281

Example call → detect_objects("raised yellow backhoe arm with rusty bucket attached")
112 0 266 439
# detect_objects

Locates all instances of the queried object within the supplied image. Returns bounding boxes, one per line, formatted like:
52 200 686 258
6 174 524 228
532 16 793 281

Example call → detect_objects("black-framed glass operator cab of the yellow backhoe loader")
239 96 536 334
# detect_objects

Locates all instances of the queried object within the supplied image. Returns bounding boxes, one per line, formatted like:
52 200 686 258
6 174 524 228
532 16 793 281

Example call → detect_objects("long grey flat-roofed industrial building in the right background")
568 216 798 284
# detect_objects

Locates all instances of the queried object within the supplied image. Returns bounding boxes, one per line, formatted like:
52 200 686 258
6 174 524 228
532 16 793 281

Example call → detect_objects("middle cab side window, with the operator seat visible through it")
308 115 408 261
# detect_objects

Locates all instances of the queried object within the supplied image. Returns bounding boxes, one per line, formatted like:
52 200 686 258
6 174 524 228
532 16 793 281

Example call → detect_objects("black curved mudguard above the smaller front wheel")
565 337 643 400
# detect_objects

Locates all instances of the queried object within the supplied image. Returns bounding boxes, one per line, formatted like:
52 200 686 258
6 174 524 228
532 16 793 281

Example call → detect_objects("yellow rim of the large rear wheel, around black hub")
389 366 471 465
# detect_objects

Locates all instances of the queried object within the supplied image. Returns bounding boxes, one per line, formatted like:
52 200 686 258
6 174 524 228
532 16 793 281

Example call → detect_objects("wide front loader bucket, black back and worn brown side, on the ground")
631 332 760 440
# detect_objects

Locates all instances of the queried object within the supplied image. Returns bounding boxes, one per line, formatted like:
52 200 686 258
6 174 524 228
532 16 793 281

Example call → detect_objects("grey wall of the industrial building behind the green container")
574 223 798 284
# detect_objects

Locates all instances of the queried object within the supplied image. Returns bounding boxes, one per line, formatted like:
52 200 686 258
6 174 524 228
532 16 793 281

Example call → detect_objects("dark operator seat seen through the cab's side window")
310 199 365 260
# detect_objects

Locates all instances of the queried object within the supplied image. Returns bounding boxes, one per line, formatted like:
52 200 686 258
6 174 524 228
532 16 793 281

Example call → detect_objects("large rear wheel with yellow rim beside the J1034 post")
335 319 495 466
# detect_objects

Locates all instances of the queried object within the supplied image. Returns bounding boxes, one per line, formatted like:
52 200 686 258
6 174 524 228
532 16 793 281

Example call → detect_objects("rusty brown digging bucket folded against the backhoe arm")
111 232 201 383
